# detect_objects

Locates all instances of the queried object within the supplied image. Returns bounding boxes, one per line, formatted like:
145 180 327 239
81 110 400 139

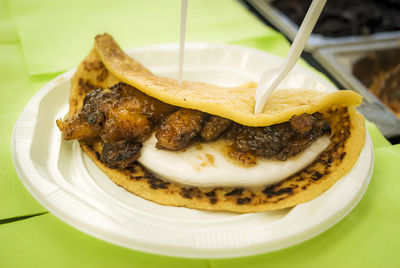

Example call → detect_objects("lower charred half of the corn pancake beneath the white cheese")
81 107 352 212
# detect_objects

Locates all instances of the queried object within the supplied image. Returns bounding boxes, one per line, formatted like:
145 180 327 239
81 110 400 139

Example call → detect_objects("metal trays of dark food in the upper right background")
242 0 400 143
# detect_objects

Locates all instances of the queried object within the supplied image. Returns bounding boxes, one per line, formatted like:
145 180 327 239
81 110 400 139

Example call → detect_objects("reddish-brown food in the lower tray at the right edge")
353 49 400 118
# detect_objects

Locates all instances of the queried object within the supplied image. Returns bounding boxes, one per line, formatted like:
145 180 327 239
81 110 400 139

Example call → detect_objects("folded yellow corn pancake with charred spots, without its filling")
70 35 365 213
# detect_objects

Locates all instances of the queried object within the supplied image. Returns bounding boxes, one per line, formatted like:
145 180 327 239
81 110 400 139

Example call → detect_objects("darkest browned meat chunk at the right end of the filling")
228 113 330 160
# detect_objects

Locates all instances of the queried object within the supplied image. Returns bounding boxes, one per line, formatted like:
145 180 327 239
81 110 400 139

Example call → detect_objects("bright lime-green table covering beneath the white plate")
0 0 400 267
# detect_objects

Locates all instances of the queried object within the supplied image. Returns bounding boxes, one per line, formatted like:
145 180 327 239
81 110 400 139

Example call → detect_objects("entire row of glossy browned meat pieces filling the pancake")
57 83 330 169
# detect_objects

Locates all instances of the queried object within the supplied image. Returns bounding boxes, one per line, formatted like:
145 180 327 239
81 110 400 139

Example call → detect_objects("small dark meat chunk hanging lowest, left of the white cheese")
100 139 142 169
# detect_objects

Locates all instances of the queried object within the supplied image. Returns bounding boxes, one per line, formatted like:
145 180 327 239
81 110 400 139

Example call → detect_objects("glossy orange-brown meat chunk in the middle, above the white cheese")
156 109 207 151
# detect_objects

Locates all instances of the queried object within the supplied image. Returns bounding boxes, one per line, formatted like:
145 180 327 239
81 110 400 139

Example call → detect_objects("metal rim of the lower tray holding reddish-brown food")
313 40 400 138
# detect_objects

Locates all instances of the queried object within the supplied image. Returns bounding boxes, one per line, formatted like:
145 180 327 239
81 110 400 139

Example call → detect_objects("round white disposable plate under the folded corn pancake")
12 44 373 258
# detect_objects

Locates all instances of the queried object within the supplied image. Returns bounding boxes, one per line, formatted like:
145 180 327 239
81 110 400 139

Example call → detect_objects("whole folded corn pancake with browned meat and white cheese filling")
57 34 365 212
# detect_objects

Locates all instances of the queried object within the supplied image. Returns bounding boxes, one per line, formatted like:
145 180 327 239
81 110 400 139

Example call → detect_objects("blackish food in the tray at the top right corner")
272 0 400 37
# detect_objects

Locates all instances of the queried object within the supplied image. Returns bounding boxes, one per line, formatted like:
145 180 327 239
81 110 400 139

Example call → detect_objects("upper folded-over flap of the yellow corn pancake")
94 34 362 126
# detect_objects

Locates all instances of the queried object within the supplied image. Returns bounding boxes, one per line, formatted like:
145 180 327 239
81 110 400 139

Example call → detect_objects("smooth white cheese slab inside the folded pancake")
138 135 330 187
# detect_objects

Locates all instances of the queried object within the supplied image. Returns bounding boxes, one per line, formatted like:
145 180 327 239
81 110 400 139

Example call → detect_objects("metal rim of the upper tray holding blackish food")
245 0 400 52
